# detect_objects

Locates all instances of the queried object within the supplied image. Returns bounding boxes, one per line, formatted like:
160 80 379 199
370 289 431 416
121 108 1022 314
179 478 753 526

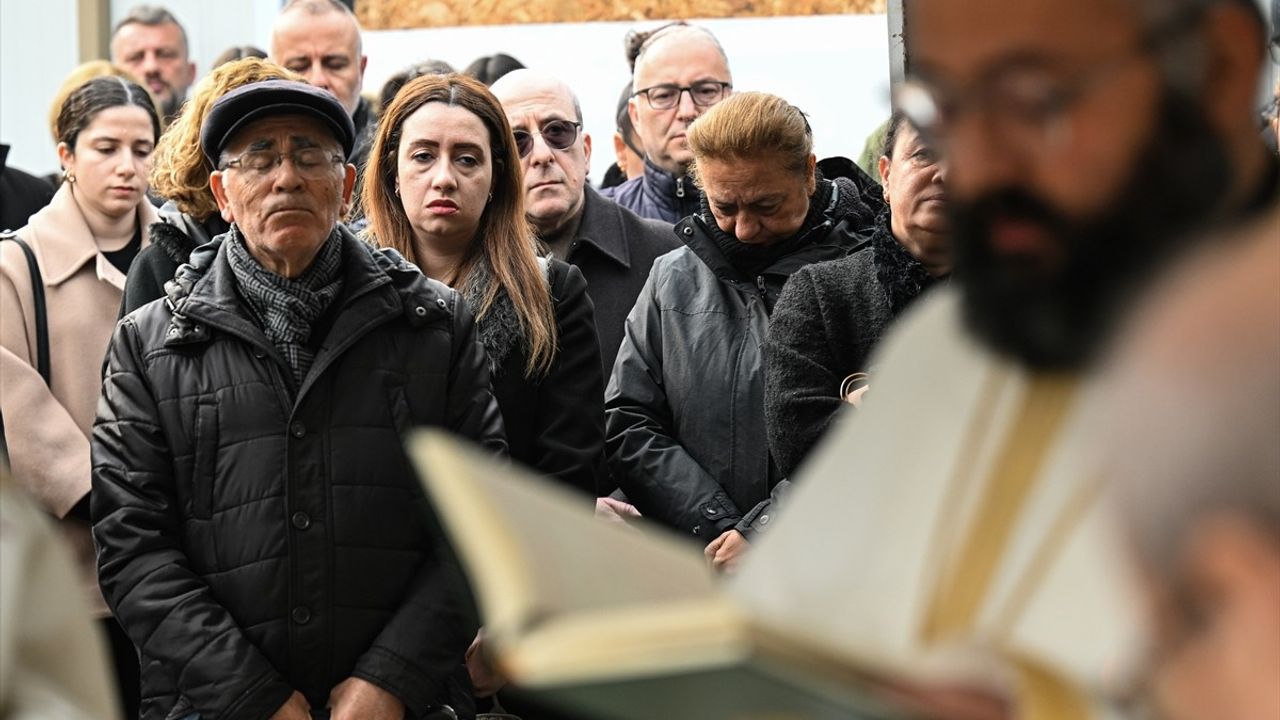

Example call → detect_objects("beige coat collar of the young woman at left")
23 182 160 290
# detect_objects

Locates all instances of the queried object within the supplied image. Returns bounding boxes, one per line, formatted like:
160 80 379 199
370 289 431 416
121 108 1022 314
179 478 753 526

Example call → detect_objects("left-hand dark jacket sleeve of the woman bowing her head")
604 273 742 542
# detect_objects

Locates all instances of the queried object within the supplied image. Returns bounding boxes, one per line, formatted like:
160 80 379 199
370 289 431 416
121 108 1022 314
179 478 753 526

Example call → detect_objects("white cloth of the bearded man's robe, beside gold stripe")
735 288 1142 707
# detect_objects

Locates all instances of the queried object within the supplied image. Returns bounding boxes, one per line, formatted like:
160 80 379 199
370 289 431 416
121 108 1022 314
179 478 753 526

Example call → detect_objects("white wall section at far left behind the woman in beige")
0 0 79 174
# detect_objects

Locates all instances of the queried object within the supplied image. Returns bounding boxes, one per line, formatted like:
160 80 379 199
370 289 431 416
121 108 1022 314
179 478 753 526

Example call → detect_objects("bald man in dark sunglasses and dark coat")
490 69 680 378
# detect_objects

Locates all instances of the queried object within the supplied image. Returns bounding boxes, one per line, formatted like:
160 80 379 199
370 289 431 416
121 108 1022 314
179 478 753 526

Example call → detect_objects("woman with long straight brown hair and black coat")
364 74 604 497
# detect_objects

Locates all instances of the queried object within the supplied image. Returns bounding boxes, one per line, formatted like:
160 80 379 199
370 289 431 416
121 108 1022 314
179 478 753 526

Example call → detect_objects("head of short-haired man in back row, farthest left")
111 5 196 119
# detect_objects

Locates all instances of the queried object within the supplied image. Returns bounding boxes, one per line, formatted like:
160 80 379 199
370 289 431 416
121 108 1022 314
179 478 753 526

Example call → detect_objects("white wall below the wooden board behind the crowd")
365 15 890 181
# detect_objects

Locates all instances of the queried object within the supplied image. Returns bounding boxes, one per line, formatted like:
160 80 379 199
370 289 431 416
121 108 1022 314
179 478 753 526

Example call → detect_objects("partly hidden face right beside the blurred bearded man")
879 123 951 275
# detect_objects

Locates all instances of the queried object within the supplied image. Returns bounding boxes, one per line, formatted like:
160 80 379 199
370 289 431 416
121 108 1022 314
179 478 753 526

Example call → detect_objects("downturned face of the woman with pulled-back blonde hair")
698 154 817 245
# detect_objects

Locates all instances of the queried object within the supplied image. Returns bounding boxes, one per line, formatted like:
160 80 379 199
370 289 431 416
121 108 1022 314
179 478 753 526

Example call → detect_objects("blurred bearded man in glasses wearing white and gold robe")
742 0 1280 717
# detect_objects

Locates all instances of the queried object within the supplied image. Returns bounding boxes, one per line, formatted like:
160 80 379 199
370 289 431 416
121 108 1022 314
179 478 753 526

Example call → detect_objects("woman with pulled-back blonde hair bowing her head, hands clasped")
605 92 883 568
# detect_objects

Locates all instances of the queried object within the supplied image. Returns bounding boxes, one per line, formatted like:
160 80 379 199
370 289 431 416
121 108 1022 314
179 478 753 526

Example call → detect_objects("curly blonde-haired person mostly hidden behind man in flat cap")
120 58 302 312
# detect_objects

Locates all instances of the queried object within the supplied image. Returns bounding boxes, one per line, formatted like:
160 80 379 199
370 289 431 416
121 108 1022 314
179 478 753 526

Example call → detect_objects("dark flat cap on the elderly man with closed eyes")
200 79 356 168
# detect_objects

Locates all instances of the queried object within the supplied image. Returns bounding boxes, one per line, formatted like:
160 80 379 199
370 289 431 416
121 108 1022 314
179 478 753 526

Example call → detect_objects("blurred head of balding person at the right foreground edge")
1103 213 1280 720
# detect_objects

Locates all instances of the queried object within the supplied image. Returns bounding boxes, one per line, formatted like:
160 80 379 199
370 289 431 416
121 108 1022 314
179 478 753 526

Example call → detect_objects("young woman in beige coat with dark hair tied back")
0 77 160 716
